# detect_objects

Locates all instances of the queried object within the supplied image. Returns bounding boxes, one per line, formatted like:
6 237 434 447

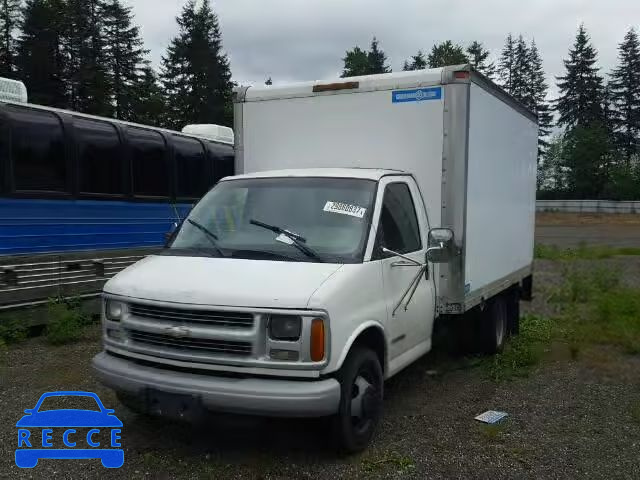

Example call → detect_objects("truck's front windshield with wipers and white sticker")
167 177 376 263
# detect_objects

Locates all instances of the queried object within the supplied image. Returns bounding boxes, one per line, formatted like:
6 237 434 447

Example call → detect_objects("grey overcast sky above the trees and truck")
125 0 640 95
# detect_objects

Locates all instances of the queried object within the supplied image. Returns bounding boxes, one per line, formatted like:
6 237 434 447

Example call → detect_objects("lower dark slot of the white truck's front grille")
128 330 251 357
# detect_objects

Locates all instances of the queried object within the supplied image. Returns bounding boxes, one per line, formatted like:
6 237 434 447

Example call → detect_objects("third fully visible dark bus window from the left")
128 127 169 197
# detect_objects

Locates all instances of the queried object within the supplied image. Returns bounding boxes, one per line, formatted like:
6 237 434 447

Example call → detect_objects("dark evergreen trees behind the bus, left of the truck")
0 0 233 129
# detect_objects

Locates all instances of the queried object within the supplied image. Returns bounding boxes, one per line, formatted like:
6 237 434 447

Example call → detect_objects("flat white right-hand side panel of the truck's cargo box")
464 83 538 303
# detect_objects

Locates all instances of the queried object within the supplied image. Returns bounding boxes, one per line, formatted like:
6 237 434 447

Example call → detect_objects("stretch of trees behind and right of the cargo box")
342 25 640 200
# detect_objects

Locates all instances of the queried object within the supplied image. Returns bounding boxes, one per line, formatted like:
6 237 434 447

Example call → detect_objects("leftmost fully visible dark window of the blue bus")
7 107 68 192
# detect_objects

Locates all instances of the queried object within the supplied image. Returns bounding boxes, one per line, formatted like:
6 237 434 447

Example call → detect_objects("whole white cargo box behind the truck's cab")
235 67 538 313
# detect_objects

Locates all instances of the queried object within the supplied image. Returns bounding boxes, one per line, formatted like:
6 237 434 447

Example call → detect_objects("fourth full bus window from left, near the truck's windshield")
173 135 213 198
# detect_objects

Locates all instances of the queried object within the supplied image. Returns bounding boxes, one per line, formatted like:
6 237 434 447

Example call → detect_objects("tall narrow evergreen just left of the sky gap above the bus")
102 0 148 120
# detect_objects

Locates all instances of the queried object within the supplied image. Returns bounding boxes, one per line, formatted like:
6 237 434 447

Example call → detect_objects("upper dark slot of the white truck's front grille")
129 303 253 329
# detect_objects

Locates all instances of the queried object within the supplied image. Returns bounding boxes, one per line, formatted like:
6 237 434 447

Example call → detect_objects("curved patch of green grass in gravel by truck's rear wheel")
485 315 553 382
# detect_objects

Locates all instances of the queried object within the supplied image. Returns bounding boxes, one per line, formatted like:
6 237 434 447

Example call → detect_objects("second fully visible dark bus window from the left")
74 118 124 195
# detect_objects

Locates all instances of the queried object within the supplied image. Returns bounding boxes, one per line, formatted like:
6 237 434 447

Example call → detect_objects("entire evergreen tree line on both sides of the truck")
0 0 640 199
